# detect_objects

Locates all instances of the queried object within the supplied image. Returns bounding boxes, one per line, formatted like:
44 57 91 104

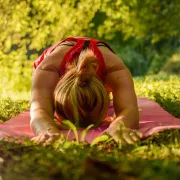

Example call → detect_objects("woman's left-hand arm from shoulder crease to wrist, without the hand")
30 68 58 135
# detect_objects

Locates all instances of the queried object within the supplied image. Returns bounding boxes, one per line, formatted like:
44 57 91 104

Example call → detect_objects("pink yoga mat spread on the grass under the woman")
0 98 180 143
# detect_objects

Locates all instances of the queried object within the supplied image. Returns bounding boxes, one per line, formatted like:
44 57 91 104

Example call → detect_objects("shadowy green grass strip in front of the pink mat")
0 130 180 180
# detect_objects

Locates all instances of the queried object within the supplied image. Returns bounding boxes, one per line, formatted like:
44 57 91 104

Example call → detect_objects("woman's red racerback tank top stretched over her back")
34 37 114 81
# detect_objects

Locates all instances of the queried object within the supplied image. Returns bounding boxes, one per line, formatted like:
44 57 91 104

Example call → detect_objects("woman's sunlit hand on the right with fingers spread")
105 120 142 144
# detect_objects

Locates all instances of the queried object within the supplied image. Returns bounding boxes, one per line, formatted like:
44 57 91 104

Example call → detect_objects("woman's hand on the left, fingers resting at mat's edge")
31 128 62 146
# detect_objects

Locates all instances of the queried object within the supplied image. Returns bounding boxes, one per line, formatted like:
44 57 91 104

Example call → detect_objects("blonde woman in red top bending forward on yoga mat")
30 37 141 145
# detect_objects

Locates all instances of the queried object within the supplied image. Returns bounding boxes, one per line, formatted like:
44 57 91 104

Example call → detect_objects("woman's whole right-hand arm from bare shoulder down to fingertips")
100 50 142 144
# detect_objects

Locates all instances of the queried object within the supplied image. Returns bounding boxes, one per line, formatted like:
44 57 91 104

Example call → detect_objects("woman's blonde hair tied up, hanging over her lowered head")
54 49 109 127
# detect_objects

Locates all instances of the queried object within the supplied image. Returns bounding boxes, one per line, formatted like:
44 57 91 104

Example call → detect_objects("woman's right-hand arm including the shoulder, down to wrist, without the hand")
104 51 139 129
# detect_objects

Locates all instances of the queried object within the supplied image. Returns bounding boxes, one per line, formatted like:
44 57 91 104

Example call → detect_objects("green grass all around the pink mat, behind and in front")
0 75 180 180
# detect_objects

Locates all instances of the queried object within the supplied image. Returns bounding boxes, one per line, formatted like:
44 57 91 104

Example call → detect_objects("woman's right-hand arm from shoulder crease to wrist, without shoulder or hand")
105 69 139 129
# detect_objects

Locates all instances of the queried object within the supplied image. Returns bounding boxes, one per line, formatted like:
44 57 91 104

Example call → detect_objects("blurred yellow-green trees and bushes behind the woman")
0 0 180 90
